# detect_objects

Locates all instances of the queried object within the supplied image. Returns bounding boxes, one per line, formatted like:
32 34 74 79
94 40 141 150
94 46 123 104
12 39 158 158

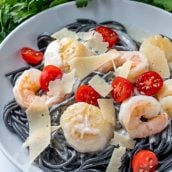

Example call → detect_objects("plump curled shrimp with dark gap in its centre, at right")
119 95 169 138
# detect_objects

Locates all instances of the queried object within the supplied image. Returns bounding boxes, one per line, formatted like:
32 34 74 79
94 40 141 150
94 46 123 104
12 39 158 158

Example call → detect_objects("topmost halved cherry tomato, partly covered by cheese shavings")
95 26 118 48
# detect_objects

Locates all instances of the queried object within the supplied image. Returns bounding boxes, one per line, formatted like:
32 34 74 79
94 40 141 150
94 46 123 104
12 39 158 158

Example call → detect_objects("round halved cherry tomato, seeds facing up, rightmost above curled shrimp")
136 71 163 96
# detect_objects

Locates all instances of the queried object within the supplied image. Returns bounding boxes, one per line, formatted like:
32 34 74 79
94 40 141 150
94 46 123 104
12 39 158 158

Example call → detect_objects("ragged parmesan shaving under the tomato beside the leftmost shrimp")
47 70 75 97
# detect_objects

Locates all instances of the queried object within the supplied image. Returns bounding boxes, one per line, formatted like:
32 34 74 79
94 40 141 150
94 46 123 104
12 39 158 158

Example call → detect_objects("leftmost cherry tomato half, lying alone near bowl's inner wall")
20 47 43 65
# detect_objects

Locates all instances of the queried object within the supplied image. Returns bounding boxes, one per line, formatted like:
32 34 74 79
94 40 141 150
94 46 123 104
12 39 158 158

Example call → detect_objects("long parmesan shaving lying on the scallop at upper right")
140 43 170 78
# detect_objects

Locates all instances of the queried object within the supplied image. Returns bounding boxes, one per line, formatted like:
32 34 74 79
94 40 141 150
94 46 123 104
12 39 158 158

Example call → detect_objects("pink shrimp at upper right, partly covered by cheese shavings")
98 51 149 83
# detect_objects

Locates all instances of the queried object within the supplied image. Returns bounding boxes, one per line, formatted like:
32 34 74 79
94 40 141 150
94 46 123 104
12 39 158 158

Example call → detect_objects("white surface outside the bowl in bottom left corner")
0 151 21 172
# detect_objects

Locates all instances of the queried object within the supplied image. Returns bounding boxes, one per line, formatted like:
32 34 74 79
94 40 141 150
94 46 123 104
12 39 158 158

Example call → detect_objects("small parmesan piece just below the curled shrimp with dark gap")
111 132 136 149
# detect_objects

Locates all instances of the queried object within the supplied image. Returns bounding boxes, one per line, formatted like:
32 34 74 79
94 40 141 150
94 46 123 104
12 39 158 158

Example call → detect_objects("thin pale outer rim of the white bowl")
0 0 172 171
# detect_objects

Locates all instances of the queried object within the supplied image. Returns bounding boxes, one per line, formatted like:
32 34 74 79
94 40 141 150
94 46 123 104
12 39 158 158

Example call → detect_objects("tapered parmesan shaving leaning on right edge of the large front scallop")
98 99 116 126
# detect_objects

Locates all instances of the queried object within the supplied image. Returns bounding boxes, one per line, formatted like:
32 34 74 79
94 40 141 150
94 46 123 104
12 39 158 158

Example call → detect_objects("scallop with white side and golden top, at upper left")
44 37 91 72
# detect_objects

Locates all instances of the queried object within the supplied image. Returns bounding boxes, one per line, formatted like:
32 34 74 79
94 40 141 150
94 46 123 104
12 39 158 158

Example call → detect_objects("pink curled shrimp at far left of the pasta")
13 68 41 108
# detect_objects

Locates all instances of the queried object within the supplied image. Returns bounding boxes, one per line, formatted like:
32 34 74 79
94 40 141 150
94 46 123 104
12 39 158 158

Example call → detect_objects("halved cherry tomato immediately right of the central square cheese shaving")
111 76 134 103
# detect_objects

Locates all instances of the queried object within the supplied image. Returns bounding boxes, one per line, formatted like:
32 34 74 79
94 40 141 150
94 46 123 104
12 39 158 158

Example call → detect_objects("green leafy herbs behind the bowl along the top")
0 0 172 42
